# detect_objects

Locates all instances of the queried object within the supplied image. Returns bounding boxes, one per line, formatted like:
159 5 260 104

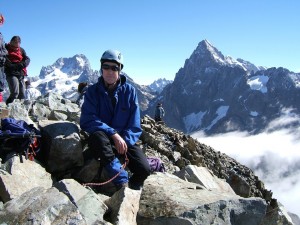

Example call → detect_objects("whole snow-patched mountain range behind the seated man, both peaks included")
25 40 300 134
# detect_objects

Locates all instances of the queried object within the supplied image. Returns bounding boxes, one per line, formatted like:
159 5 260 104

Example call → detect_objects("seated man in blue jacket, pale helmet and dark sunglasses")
80 50 151 190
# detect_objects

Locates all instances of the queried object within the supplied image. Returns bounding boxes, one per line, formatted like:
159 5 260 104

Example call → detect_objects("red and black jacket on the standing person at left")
4 44 30 77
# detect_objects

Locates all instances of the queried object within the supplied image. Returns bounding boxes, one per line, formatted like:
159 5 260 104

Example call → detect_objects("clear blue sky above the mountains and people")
0 0 300 84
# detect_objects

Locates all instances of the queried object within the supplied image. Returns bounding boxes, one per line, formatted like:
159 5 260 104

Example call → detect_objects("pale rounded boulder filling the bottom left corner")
0 187 87 225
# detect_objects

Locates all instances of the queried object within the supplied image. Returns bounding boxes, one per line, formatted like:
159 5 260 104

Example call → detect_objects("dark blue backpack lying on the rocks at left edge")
0 118 41 162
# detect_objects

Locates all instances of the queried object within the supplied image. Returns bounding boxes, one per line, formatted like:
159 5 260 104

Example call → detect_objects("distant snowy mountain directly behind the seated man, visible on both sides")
30 54 156 110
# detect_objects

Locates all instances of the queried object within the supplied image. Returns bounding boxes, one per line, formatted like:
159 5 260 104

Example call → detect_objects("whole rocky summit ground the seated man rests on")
0 93 294 225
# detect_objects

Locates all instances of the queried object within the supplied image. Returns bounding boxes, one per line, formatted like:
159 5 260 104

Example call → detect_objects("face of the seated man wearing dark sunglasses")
101 62 120 85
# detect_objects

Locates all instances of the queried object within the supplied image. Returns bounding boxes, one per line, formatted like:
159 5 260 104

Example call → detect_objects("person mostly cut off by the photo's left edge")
0 14 7 102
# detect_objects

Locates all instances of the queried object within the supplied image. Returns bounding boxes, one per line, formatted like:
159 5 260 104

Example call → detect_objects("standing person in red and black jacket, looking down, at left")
4 36 30 104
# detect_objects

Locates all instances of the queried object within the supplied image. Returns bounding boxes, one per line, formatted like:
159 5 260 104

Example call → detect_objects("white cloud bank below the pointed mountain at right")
192 130 300 216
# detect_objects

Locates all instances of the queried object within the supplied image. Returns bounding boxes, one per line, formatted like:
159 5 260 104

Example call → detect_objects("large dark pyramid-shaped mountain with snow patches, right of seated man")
143 40 300 134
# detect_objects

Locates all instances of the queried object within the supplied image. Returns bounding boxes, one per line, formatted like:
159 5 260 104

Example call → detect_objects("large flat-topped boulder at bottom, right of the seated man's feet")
137 173 267 225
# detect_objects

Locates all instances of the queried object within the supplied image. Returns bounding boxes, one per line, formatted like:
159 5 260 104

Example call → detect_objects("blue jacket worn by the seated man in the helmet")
80 75 142 146
